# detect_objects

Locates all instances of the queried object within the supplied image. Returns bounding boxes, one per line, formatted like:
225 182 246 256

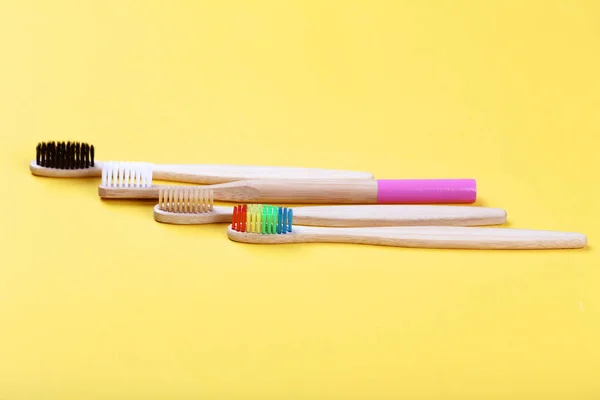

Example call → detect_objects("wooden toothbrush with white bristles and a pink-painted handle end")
98 163 477 204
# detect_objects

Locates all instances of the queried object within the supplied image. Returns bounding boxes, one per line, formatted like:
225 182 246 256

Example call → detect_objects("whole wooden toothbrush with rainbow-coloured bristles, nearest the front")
227 207 587 250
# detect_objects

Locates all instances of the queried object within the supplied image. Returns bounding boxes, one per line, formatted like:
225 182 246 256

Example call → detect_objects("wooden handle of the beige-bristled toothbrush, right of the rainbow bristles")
293 205 506 227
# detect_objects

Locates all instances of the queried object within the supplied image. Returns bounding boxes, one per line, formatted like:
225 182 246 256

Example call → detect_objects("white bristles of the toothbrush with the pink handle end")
102 161 152 188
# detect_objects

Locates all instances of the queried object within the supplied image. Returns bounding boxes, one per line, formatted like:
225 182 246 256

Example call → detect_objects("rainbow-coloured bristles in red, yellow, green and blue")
231 204 293 235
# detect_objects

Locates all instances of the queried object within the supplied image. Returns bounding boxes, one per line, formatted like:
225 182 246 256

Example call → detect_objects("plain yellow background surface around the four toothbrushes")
0 0 600 399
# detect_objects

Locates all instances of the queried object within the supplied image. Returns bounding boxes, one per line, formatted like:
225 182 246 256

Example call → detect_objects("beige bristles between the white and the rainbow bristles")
158 186 213 214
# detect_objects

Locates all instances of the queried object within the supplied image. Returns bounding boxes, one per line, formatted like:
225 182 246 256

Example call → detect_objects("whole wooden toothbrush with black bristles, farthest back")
29 142 373 184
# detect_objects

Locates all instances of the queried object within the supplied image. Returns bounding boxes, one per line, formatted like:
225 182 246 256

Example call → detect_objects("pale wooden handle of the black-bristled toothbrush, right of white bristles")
152 164 373 184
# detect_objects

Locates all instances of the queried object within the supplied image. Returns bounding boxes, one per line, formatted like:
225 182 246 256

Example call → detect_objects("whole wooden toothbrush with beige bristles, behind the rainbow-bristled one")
154 186 506 226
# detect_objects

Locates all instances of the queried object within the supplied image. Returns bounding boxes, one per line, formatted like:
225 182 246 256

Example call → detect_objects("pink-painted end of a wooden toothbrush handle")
377 179 477 204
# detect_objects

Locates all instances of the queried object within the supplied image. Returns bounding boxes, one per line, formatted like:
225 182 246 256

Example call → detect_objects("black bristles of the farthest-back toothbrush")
35 142 94 169
